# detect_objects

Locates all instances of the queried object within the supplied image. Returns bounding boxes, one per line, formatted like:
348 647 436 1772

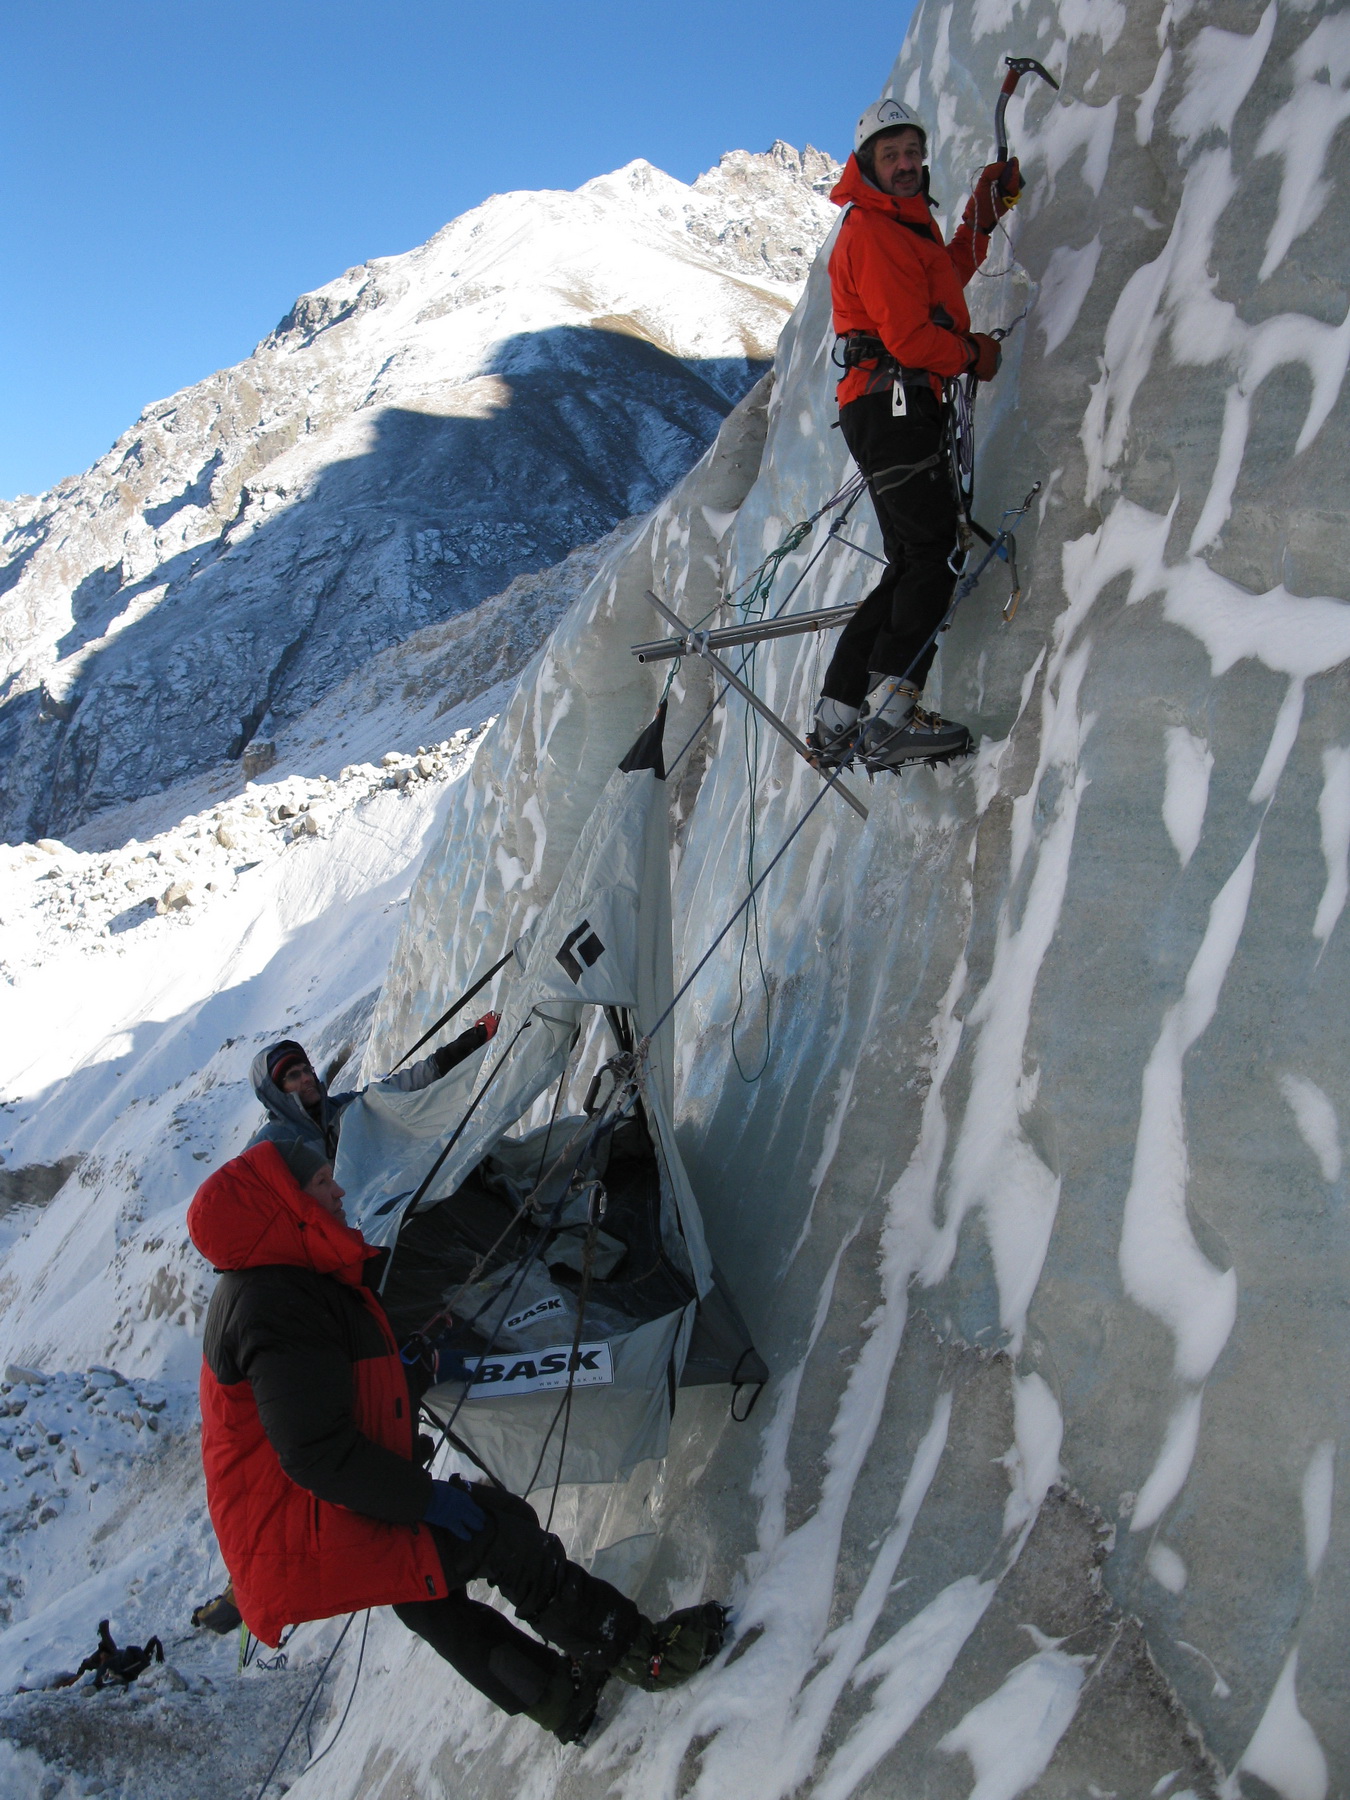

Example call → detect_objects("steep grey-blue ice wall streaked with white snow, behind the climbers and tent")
361 0 1350 1800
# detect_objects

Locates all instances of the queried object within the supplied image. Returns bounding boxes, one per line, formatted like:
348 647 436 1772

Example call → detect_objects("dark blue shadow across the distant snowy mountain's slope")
0 326 767 842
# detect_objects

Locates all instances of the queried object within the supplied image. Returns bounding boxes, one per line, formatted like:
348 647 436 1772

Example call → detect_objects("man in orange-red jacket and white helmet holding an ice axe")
808 99 1021 769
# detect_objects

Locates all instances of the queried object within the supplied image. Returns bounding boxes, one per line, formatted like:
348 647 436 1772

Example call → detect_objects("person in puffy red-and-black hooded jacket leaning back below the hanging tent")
187 1136 725 1742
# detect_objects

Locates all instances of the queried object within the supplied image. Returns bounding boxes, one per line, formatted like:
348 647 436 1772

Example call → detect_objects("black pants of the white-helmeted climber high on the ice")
821 387 958 706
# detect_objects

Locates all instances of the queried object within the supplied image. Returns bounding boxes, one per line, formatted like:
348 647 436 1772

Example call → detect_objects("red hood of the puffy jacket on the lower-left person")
187 1143 380 1287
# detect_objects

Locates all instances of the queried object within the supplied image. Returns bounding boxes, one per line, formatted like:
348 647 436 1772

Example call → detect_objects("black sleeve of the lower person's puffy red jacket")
230 1269 432 1525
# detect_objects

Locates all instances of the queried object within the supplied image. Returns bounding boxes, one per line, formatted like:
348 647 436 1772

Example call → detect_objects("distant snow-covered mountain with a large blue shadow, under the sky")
0 144 835 841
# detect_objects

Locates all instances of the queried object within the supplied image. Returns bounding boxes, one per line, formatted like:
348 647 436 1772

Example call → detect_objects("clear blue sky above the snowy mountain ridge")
0 0 911 497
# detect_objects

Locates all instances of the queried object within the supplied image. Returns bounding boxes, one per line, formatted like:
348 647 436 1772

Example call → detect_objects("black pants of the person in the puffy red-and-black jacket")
394 1483 643 1712
